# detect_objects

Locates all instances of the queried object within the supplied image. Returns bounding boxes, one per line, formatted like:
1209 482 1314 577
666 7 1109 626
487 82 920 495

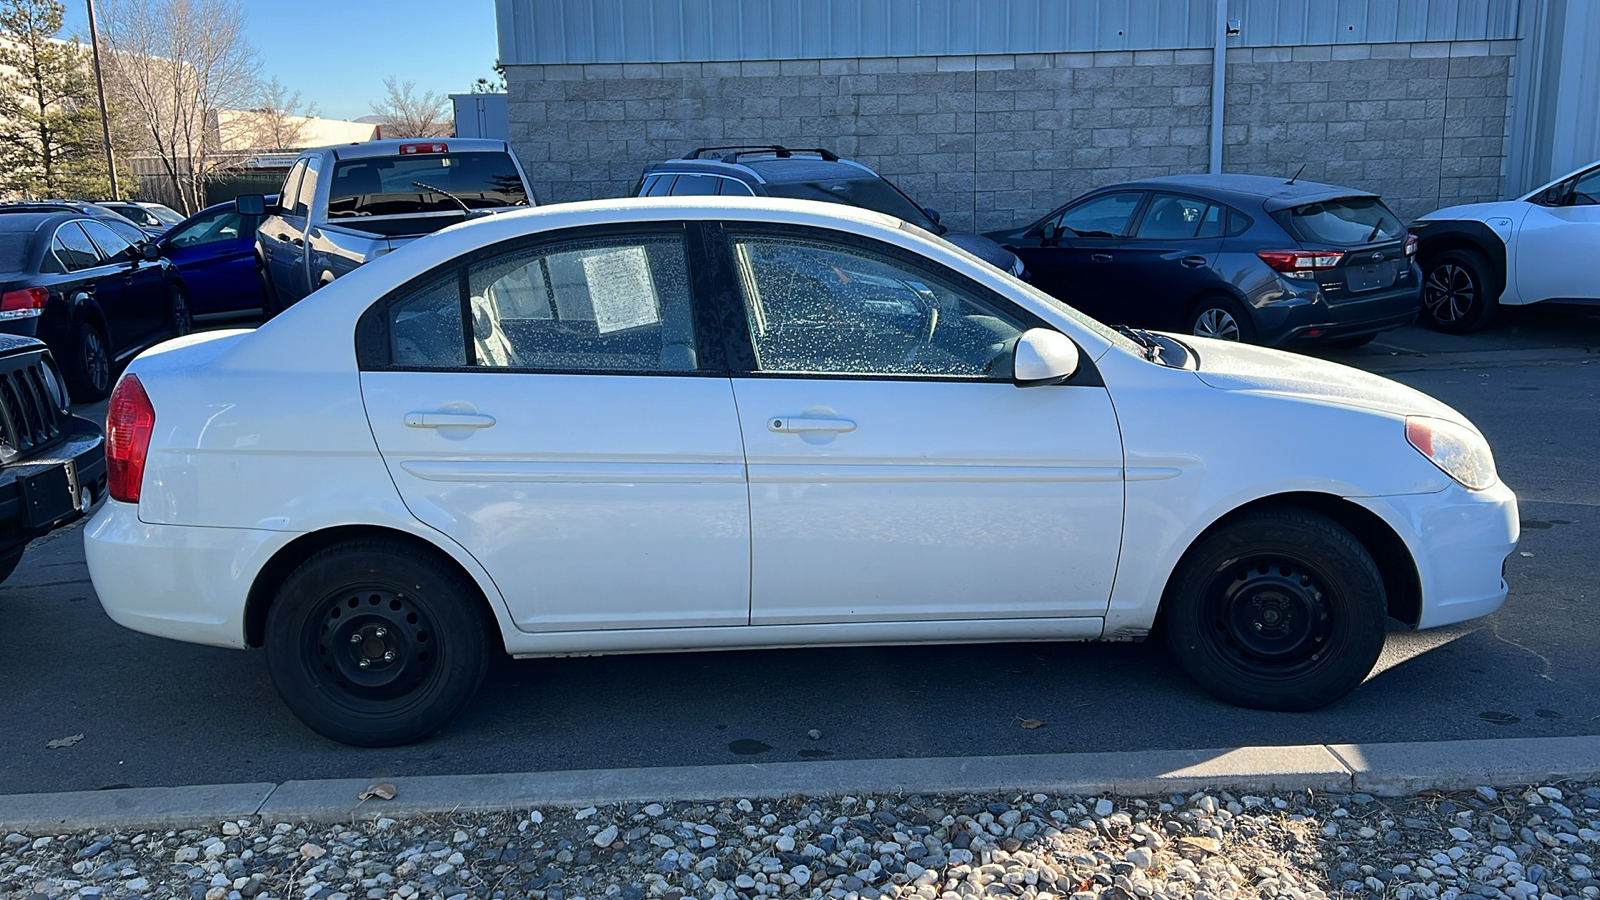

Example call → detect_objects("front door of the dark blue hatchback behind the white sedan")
1016 191 1144 322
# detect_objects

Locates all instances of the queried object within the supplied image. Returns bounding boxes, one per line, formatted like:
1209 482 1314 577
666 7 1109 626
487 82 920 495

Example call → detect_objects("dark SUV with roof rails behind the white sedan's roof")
634 146 1027 279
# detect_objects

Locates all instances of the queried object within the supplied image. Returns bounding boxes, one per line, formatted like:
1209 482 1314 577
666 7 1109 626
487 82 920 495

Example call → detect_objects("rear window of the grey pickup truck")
328 152 528 219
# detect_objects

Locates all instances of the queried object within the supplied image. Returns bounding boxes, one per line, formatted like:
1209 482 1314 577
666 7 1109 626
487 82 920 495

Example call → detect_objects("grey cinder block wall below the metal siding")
506 42 1515 231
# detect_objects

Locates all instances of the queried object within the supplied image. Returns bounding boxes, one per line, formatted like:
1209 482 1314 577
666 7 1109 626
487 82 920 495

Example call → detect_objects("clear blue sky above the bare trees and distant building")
62 0 499 119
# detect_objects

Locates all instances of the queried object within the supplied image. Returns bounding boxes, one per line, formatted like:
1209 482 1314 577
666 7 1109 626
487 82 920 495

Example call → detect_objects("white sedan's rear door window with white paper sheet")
467 235 699 373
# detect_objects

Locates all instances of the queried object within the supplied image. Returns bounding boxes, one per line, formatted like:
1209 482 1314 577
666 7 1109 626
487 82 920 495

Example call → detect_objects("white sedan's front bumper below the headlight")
1350 484 1520 629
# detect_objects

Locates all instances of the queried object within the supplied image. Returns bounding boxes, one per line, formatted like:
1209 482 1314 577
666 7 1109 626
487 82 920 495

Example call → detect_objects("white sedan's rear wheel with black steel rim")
266 540 488 746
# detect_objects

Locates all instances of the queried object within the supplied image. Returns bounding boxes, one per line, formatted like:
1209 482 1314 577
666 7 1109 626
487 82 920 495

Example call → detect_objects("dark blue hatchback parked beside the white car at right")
989 175 1422 346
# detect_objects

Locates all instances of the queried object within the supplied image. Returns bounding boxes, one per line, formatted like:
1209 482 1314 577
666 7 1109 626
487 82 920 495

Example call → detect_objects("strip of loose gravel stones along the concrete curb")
0 783 1600 900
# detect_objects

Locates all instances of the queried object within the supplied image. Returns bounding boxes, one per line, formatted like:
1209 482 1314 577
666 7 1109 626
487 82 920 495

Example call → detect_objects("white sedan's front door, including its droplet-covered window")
713 226 1123 625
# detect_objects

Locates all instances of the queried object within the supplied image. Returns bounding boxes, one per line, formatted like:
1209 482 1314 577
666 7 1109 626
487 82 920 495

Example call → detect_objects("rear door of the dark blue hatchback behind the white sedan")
1107 194 1227 330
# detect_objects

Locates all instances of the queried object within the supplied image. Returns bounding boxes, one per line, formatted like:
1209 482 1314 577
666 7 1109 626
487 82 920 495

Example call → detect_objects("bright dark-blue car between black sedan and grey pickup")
160 200 262 317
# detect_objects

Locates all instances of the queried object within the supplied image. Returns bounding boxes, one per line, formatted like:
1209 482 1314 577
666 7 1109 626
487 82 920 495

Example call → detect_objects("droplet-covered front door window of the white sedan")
730 235 1022 380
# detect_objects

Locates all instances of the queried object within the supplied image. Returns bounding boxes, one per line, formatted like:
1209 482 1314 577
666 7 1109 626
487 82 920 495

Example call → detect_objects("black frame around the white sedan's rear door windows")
355 219 728 378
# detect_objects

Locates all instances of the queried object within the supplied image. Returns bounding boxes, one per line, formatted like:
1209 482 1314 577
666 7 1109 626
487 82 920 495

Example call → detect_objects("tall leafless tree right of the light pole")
101 0 261 213
